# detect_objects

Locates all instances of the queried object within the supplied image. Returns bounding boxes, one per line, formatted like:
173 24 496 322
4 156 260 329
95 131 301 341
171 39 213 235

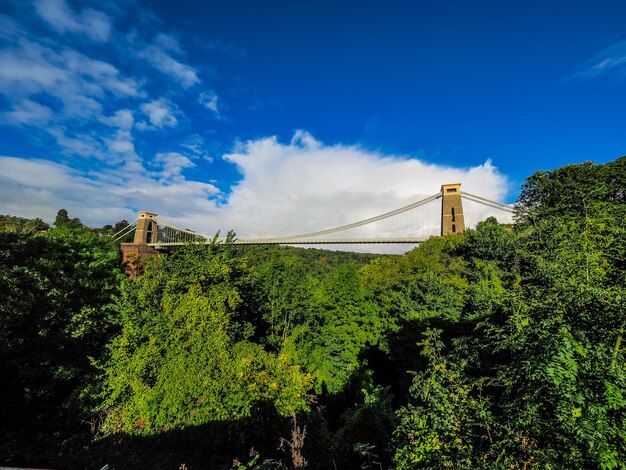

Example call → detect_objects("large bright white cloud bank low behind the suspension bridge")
0 132 511 252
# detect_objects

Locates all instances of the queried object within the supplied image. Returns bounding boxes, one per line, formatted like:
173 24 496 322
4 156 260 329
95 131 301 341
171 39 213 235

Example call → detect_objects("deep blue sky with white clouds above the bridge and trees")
0 0 626 241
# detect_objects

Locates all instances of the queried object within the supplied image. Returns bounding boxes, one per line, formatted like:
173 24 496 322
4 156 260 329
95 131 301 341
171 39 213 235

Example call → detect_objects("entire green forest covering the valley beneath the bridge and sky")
0 157 626 470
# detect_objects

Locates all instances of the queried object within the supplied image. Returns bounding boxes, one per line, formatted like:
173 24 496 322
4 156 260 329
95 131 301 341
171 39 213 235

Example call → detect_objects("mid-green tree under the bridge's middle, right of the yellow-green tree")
251 250 388 393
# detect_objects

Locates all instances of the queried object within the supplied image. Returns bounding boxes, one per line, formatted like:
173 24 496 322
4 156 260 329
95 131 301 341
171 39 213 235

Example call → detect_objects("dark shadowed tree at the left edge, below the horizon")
0 229 121 451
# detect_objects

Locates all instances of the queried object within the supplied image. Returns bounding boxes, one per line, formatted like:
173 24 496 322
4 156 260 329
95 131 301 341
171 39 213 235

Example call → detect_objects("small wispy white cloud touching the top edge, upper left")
35 0 111 42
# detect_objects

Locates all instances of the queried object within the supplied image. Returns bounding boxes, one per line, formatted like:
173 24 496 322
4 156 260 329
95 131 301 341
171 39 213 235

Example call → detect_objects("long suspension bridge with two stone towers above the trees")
113 183 514 255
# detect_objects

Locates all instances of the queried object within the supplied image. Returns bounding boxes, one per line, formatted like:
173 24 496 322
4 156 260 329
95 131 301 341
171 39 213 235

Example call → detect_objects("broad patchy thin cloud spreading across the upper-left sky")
0 0 205 165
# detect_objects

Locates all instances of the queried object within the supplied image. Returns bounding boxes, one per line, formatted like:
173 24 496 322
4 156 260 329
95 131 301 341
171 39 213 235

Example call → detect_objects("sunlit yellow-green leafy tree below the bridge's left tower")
95 245 310 434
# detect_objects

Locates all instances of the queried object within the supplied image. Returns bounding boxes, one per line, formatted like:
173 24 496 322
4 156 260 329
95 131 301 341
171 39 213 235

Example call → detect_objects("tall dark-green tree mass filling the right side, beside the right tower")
395 159 626 468
